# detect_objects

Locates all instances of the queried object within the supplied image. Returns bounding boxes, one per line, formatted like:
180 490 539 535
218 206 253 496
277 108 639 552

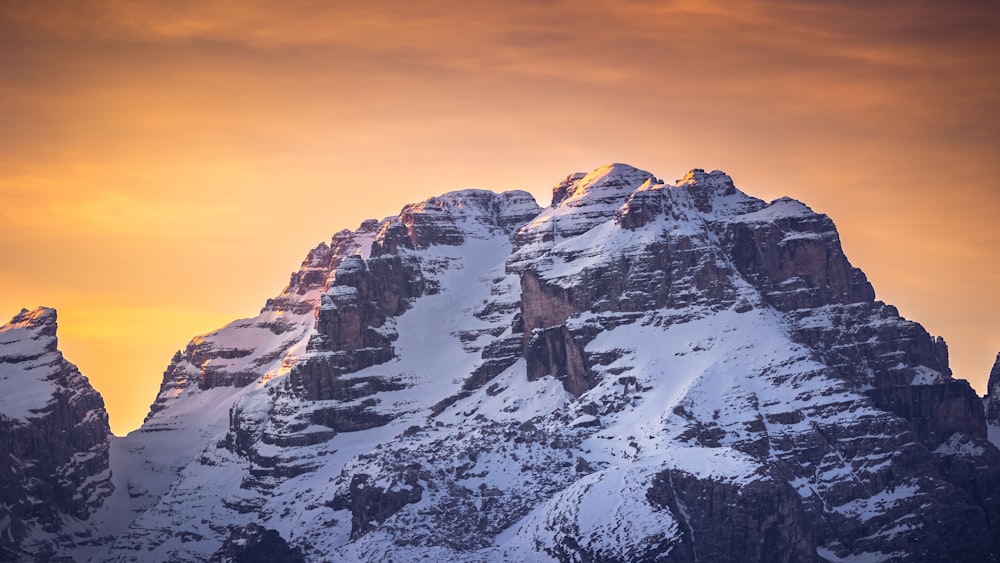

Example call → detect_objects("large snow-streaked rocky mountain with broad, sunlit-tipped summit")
1 164 1000 562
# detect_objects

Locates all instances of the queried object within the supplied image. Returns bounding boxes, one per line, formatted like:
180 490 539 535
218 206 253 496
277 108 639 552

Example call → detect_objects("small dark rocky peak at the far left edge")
0 307 112 561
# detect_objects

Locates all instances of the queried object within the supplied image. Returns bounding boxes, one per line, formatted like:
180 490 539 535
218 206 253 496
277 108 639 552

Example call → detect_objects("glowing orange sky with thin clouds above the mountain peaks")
0 0 1000 433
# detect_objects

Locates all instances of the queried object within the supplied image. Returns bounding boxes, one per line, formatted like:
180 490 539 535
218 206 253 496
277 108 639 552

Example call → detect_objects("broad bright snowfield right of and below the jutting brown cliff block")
581 311 818 480
